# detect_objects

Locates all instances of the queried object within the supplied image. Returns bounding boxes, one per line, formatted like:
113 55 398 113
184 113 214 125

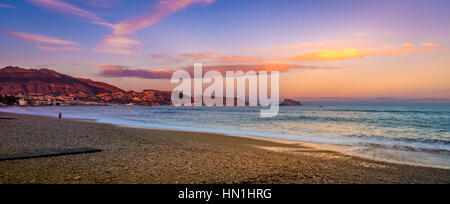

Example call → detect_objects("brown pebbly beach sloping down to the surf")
0 112 450 184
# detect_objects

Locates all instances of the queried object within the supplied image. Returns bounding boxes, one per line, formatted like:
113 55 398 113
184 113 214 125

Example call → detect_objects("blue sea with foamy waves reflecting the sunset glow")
0 103 450 169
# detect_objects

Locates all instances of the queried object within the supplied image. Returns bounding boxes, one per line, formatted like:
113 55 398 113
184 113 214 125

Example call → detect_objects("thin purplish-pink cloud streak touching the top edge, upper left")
27 0 111 27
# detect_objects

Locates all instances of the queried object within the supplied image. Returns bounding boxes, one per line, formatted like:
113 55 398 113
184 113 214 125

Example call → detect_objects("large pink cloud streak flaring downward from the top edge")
93 0 214 55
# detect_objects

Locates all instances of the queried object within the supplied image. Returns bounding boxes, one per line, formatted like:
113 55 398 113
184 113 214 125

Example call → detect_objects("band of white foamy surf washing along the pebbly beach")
0 108 450 169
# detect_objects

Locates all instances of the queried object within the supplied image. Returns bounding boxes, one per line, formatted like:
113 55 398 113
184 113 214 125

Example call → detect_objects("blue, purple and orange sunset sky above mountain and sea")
0 0 450 99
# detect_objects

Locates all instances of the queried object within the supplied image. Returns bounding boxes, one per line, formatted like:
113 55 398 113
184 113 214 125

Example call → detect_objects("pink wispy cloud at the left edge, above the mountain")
0 29 80 51
